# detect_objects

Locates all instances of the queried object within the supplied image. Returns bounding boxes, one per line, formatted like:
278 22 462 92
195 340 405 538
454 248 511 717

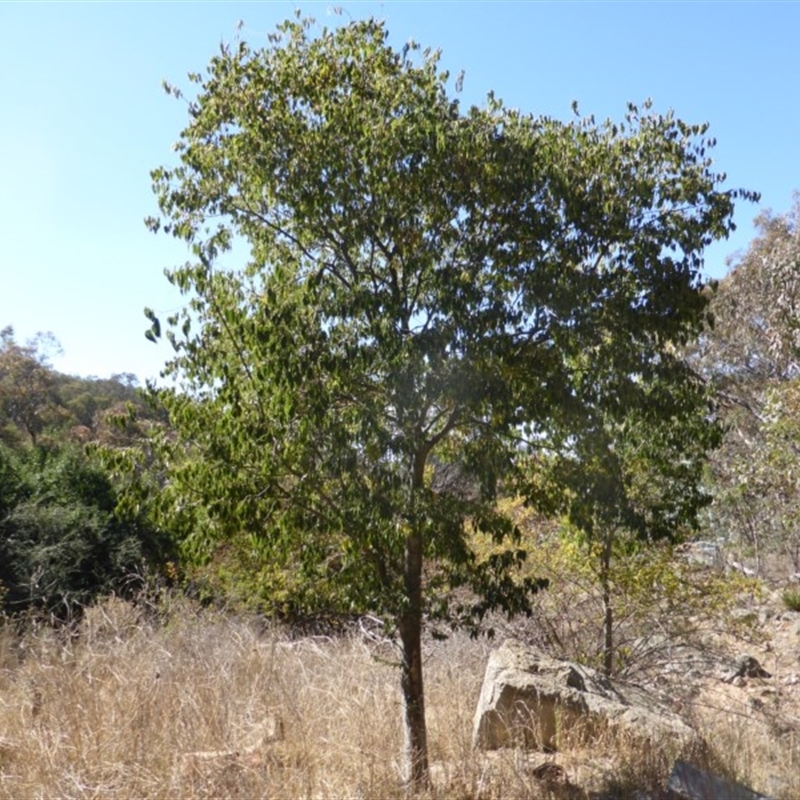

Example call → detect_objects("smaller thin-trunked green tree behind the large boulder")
537 357 721 676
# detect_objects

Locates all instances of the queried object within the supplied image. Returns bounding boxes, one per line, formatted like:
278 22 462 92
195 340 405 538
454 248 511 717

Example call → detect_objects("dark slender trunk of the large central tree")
398 458 430 793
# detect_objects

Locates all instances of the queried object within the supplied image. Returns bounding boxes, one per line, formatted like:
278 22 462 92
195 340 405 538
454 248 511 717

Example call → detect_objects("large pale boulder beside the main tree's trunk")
473 639 703 755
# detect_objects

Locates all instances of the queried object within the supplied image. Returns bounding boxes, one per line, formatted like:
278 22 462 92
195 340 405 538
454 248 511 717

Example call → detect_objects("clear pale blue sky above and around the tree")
0 0 800 379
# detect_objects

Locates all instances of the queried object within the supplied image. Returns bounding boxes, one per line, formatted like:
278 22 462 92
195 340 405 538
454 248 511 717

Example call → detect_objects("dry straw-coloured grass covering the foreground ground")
0 599 800 800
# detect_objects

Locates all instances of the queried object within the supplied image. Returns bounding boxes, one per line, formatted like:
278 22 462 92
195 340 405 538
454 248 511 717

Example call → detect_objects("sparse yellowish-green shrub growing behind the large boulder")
490 498 759 679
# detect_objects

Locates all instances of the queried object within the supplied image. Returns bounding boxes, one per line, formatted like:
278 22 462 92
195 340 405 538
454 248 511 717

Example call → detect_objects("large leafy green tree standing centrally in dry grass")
147 20 756 789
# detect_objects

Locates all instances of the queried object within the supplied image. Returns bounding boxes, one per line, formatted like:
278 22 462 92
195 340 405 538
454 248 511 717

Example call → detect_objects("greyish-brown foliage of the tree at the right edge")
694 197 800 570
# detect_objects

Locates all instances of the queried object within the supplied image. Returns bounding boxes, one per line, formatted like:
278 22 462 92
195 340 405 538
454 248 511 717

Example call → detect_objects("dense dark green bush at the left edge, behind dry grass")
0 445 171 618
